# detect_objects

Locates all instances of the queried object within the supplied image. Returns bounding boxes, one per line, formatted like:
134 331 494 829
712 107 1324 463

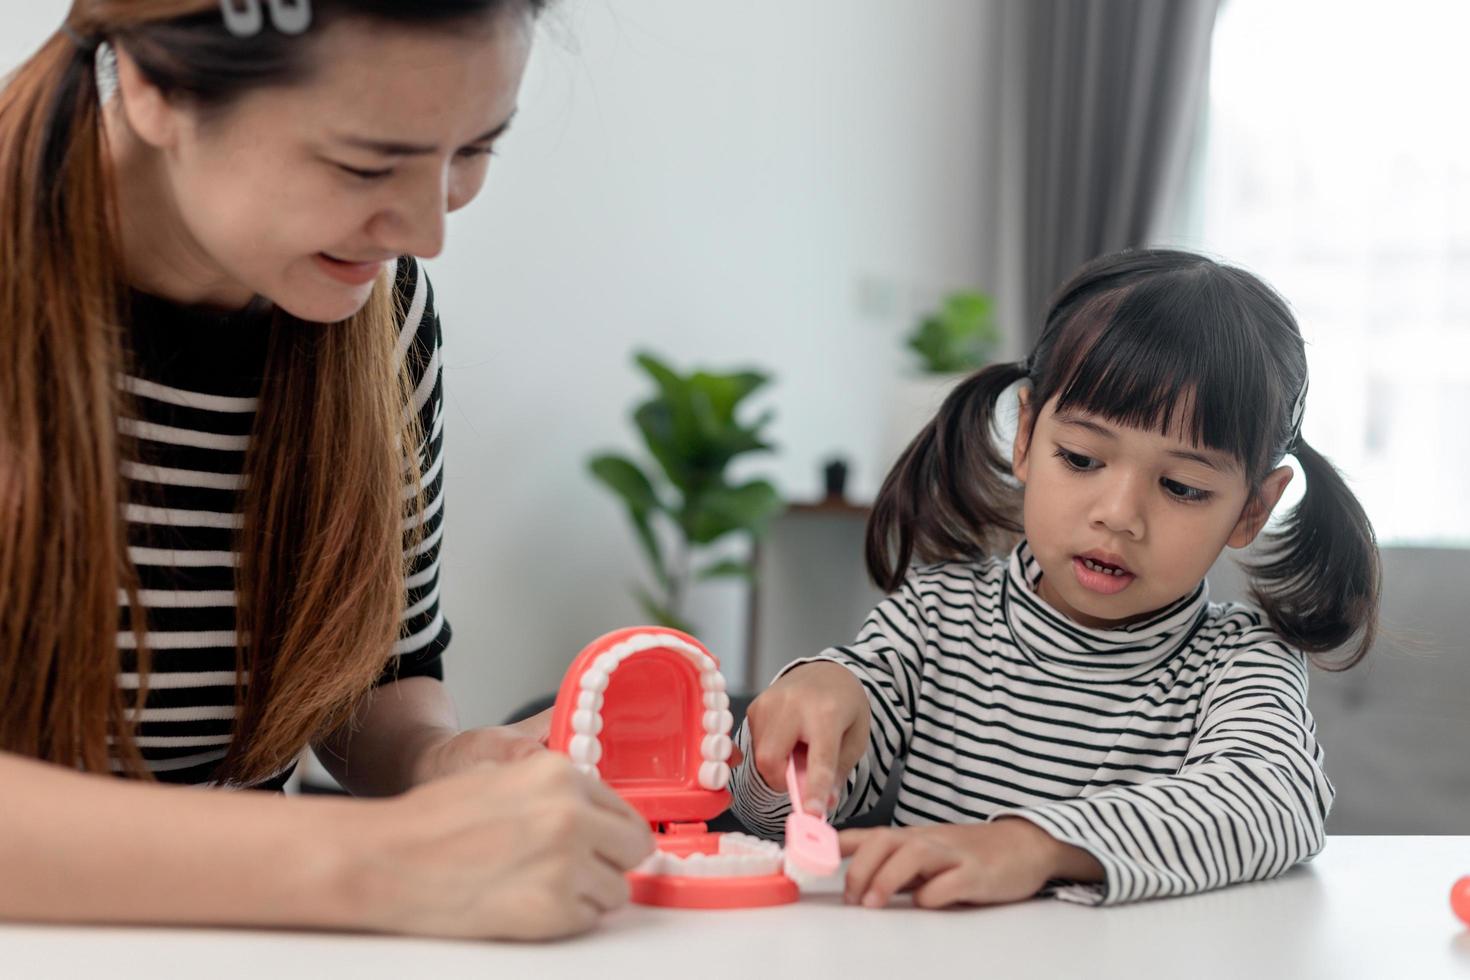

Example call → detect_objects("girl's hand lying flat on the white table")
839 818 1103 908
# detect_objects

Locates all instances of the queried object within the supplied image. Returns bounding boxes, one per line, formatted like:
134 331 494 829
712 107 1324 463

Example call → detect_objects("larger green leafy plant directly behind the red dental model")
588 353 782 633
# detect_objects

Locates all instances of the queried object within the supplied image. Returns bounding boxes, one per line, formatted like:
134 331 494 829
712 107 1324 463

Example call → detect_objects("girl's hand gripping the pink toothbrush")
745 661 870 815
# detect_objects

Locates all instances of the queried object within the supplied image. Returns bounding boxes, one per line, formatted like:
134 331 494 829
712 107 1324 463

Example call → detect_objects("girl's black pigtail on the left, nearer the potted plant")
867 361 1028 592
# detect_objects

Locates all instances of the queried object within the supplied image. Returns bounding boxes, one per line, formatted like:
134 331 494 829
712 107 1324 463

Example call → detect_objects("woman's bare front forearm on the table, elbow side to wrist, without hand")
0 754 360 929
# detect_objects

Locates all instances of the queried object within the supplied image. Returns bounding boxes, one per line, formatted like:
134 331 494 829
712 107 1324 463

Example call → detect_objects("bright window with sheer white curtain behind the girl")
1182 0 1470 545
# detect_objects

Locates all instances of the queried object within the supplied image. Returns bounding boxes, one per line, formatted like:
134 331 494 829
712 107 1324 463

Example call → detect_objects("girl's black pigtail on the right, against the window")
1245 439 1380 670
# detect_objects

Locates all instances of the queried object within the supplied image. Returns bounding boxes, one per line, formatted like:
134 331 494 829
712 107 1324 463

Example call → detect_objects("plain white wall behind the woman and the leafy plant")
0 0 992 723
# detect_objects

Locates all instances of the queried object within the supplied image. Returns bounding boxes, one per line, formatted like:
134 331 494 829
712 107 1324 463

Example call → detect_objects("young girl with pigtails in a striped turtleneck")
734 250 1379 907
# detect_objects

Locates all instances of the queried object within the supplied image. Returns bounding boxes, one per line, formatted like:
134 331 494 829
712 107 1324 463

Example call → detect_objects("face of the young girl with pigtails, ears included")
1013 392 1292 629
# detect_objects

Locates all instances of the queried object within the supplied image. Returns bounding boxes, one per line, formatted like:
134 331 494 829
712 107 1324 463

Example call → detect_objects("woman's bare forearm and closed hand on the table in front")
0 752 651 939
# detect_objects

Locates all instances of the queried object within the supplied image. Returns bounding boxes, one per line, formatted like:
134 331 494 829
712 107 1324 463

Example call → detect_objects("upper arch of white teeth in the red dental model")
567 633 735 787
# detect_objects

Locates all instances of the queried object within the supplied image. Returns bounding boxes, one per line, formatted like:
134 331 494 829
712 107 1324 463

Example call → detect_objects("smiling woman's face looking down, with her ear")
109 12 532 322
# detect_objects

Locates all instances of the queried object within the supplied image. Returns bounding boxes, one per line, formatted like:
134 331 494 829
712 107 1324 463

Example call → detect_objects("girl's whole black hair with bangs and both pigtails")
867 248 1380 670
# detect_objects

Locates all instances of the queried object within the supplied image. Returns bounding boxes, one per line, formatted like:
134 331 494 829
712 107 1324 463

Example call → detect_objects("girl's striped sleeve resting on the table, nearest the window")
992 630 1333 904
